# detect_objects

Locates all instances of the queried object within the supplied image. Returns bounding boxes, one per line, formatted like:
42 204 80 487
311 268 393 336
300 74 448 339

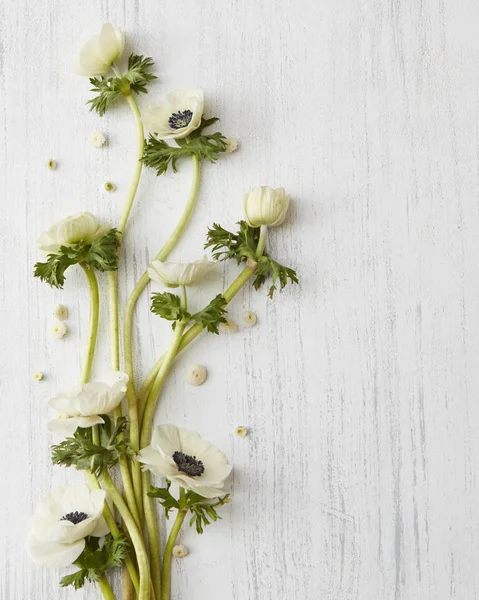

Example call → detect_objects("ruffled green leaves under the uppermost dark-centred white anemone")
141 117 226 175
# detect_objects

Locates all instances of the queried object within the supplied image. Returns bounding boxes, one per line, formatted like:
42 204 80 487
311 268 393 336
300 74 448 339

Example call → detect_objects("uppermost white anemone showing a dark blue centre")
142 89 204 140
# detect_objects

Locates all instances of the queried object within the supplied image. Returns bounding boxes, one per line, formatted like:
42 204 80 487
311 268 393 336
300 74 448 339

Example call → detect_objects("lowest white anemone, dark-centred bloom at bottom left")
27 484 108 568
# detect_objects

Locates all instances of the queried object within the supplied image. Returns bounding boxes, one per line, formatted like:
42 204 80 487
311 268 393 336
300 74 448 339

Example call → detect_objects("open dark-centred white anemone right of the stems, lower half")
138 425 232 498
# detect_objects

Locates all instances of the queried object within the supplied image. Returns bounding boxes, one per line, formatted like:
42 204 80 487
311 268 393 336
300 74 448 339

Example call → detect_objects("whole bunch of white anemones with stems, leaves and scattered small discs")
27 24 297 600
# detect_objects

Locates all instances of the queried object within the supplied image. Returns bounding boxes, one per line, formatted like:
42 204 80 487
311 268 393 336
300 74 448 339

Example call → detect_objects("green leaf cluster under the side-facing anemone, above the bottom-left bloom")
52 415 133 477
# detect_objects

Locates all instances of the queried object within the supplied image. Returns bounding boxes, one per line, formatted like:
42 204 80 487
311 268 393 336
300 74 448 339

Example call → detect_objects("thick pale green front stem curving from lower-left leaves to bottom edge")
103 471 150 600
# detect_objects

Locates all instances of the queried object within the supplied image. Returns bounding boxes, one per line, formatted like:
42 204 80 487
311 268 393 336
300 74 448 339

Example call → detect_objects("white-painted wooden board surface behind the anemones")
0 0 479 600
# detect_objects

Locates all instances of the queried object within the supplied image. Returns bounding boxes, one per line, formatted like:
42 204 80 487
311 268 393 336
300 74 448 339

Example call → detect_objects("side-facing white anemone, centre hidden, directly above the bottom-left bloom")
48 371 128 437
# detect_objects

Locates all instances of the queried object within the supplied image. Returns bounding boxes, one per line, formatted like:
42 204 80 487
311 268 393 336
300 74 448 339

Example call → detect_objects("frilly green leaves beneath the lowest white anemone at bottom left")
60 534 129 590
